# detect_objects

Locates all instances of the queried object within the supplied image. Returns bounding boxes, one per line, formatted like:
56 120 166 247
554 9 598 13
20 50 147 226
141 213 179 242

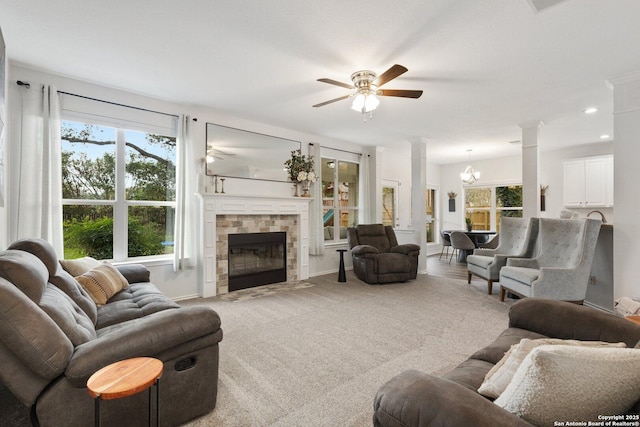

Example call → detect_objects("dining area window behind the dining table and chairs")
464 185 522 232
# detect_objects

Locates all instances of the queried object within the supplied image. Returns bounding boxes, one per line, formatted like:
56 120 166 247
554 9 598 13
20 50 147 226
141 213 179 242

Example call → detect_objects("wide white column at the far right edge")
610 70 640 299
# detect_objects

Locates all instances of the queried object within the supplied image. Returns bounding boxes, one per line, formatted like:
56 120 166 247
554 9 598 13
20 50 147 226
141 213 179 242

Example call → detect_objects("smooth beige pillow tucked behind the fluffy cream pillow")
478 338 626 399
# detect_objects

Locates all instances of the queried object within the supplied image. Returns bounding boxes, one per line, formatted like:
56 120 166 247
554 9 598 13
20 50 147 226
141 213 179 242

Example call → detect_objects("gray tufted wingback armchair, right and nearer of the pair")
500 218 602 304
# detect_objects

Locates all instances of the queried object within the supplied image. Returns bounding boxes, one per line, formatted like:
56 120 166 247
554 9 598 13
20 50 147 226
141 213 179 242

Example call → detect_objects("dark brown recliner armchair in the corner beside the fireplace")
347 224 420 284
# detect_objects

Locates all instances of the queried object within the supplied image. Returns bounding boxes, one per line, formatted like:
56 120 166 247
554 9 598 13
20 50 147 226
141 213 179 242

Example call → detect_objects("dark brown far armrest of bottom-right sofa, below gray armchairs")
509 298 640 347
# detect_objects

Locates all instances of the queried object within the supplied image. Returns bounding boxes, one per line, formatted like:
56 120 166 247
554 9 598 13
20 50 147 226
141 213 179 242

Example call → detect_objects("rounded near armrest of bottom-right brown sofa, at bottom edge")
373 370 531 427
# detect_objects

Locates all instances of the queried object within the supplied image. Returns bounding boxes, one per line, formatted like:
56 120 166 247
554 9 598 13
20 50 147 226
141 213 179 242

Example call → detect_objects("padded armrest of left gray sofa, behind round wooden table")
65 307 222 387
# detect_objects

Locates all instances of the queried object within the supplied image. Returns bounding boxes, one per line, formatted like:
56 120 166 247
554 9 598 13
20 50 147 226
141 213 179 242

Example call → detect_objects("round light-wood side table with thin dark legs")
87 357 163 426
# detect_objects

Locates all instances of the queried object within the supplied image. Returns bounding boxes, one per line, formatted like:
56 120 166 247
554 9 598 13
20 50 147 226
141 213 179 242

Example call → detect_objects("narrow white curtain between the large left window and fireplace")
173 114 191 271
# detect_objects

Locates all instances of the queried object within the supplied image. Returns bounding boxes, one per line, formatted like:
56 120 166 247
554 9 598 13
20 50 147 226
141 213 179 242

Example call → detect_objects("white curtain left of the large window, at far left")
9 83 64 258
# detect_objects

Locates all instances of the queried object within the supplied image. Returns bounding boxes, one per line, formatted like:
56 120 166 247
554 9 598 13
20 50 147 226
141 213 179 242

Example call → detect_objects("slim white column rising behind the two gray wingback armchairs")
520 121 544 218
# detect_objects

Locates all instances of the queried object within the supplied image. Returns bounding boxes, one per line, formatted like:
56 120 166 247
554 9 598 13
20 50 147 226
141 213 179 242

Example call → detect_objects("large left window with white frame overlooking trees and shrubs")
62 120 176 261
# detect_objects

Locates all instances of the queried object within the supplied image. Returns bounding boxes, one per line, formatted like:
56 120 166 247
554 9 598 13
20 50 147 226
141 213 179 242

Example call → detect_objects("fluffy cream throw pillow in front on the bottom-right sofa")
494 345 640 425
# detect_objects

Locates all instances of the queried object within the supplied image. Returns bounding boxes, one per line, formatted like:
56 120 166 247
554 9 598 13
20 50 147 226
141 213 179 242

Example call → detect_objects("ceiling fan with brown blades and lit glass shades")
314 64 422 120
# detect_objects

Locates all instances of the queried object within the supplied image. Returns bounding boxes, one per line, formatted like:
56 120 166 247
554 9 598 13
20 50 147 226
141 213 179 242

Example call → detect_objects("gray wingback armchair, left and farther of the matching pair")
467 217 538 295
